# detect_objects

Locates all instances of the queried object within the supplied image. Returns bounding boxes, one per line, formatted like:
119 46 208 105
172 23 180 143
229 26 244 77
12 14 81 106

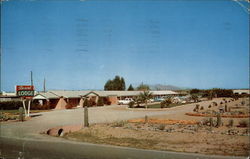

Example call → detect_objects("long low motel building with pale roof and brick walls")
33 90 179 109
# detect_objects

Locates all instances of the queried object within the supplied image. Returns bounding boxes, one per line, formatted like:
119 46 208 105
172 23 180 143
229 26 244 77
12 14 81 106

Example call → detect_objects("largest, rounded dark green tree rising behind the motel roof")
104 76 126 90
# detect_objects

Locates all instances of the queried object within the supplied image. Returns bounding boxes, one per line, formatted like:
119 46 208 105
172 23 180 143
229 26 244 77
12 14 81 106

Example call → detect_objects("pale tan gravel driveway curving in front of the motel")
0 101 224 138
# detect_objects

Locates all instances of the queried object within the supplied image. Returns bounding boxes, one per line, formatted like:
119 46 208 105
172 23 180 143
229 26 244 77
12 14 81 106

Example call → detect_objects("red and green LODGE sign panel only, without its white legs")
16 85 35 97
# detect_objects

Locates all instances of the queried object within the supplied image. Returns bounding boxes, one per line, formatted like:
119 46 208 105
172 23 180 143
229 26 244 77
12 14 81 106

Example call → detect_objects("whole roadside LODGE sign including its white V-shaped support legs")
16 85 35 117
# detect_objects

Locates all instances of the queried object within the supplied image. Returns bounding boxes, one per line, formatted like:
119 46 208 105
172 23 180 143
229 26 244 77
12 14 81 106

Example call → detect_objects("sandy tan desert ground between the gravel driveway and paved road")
64 98 250 156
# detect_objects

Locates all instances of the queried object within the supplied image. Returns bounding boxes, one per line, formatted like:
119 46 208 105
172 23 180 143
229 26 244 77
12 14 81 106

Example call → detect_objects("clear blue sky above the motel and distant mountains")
1 0 249 91
